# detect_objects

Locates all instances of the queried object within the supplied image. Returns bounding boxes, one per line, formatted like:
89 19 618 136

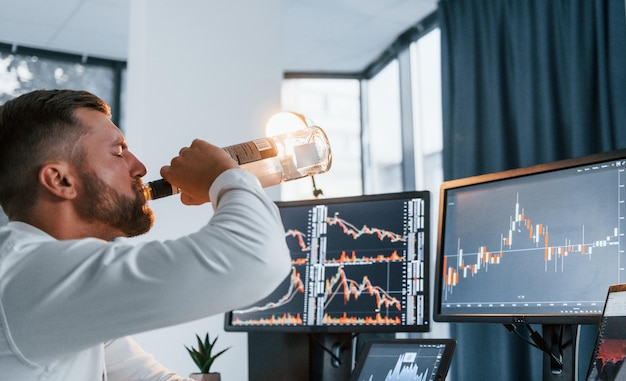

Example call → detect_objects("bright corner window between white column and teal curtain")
281 21 443 205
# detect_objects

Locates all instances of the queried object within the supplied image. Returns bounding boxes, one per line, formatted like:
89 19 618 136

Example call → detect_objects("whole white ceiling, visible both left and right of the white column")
0 0 437 73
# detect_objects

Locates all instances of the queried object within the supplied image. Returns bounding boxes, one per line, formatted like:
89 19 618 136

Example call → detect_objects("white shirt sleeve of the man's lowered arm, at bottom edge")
104 336 193 381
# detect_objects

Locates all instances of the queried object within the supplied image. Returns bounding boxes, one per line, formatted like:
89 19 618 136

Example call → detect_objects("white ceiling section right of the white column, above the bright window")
283 0 437 72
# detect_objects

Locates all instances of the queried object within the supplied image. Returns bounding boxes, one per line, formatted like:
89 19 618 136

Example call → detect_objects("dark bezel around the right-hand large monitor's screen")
432 149 626 324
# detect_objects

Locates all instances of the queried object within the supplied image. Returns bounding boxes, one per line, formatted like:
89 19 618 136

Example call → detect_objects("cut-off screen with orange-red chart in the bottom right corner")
586 284 626 381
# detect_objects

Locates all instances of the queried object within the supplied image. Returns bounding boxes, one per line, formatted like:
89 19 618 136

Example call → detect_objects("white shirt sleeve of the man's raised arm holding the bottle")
0 169 291 362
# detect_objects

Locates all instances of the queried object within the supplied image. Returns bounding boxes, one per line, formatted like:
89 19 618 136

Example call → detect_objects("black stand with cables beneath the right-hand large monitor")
541 324 579 381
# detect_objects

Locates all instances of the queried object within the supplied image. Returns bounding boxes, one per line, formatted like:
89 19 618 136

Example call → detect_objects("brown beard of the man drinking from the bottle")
78 172 154 237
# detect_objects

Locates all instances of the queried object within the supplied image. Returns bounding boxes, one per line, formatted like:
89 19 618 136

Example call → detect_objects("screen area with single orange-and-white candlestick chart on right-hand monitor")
438 163 626 313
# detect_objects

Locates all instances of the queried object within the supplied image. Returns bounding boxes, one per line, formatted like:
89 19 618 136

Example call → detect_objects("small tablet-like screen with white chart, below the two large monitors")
350 339 456 381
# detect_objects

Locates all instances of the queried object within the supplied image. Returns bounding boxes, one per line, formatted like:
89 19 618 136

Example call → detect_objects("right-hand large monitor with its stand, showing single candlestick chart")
433 150 626 379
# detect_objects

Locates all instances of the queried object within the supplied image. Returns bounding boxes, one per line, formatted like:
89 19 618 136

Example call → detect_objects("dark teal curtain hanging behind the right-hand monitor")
438 0 626 381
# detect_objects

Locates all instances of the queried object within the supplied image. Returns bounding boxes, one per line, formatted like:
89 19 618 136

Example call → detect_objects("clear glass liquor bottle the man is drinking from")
144 126 332 200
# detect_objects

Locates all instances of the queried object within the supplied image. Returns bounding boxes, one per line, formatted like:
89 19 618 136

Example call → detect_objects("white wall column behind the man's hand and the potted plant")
124 0 282 381
